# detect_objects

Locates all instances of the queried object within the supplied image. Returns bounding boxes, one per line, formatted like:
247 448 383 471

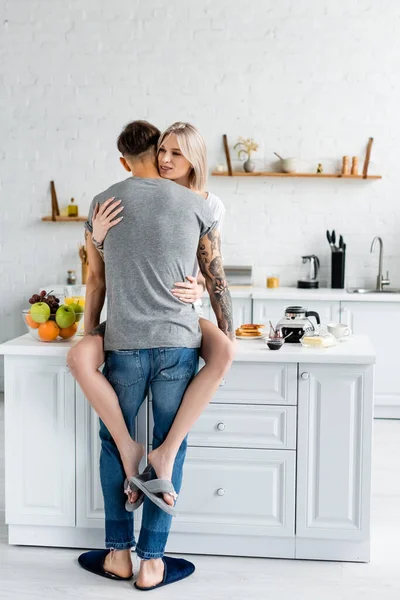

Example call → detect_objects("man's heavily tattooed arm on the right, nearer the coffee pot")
197 229 235 341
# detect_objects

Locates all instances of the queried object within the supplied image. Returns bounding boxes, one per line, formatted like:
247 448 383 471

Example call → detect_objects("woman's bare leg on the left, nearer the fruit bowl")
67 334 144 490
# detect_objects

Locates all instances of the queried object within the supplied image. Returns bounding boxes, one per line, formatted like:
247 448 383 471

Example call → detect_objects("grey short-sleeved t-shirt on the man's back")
85 177 216 350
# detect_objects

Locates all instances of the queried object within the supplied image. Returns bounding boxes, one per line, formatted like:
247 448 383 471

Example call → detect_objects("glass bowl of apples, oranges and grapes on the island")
22 290 83 342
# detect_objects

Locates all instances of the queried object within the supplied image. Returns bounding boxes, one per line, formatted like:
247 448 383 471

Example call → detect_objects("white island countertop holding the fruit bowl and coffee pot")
0 333 375 365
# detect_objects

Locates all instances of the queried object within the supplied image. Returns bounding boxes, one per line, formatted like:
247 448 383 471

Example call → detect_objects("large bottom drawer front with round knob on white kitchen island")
172 448 296 537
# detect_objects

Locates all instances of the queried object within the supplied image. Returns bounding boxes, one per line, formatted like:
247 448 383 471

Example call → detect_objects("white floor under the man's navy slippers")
0 398 400 600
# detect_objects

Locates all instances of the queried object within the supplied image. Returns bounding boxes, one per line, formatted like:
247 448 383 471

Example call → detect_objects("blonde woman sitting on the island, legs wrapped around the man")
68 122 234 510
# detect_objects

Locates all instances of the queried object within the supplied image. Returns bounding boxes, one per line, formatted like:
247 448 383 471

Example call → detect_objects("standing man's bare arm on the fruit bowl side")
84 230 106 335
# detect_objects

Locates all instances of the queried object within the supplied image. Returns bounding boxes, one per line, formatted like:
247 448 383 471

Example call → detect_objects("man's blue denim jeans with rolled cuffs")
100 348 198 559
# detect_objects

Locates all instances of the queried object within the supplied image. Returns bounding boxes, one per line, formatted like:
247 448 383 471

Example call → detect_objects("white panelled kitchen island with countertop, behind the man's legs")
0 334 375 561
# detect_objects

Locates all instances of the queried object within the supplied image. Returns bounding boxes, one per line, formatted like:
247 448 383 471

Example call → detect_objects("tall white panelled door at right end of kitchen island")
296 364 373 558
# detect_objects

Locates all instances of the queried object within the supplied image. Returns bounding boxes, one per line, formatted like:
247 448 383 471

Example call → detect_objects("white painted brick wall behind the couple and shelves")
0 0 400 392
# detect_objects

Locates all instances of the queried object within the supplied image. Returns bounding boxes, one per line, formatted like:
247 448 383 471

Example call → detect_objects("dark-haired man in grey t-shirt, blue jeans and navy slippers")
79 121 234 589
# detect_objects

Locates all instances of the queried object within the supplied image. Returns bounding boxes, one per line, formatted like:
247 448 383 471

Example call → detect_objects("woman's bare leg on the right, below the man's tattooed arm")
148 319 235 505
